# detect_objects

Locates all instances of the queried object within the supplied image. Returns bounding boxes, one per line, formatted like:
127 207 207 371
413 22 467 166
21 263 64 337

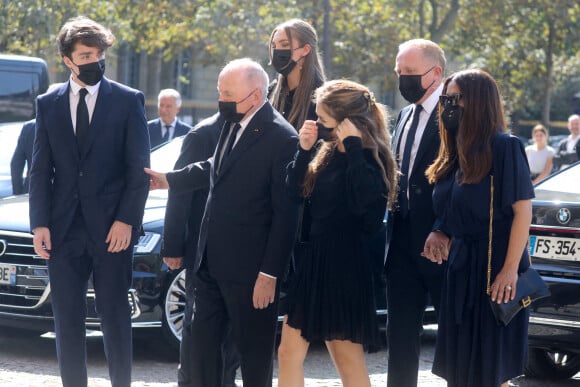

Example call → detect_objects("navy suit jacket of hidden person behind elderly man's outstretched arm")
161 113 225 268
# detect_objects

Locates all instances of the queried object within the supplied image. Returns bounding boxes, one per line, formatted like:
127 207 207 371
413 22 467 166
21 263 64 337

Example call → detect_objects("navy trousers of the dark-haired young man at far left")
48 212 133 387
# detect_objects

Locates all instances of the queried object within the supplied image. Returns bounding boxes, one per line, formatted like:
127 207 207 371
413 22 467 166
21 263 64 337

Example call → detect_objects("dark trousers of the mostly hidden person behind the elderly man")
177 268 240 387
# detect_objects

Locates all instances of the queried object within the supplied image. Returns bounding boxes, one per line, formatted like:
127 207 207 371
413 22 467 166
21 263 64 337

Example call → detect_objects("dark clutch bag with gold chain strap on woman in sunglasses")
487 175 550 326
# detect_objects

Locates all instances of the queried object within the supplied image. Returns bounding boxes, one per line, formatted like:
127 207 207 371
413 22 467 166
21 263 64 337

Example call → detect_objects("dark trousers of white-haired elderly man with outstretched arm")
191 264 278 387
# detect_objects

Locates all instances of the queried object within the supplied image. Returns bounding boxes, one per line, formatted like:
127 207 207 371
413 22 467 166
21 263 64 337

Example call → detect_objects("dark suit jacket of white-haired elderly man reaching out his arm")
167 102 298 284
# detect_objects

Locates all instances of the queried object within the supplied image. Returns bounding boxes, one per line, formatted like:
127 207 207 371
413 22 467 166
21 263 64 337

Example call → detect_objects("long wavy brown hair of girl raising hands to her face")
304 80 398 208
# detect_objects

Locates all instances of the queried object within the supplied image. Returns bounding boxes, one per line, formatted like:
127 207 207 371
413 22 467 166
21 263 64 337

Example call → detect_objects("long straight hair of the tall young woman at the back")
269 19 325 130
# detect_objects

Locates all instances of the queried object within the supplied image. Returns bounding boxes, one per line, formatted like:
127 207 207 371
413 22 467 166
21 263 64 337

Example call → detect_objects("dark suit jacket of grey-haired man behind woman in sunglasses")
386 105 441 261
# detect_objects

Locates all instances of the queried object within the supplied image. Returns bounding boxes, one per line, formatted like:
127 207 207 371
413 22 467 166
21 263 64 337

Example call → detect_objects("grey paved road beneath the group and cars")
0 330 580 387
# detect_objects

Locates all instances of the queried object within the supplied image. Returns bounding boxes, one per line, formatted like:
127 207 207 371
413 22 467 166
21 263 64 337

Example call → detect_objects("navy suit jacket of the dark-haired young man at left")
29 78 150 250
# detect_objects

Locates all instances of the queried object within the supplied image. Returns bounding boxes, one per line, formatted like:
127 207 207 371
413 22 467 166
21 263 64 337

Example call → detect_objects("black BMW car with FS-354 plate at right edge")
526 163 580 379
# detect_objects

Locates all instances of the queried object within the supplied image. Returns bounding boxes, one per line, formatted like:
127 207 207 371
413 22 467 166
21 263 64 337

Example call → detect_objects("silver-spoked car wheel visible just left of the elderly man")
162 270 185 350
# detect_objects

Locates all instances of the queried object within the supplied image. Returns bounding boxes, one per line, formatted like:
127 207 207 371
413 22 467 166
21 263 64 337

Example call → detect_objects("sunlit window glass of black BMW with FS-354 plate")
534 163 580 203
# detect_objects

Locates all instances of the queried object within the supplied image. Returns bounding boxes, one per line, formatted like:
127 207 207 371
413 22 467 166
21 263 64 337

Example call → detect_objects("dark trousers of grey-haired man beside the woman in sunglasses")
386 219 446 387
